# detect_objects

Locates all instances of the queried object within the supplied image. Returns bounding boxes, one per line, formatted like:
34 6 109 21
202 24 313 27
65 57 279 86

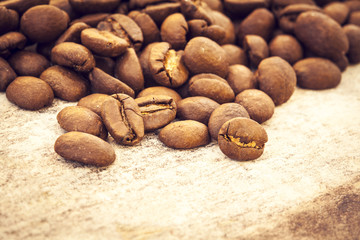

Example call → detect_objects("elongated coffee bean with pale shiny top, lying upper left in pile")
81 28 129 57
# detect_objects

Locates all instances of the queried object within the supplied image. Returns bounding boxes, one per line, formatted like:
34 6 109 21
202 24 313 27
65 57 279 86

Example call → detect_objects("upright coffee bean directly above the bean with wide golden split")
160 13 188 50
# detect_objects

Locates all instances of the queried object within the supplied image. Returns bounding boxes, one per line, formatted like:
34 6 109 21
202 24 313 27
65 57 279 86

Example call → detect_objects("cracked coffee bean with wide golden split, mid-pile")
148 42 189 88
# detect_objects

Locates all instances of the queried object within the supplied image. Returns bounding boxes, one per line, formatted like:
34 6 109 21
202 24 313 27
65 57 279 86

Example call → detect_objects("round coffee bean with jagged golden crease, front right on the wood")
218 117 268 161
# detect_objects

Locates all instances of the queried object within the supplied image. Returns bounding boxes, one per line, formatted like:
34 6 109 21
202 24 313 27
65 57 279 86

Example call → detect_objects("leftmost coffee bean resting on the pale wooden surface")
6 77 54 110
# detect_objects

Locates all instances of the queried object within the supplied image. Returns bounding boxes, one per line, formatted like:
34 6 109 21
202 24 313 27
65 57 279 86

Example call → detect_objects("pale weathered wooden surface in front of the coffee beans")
0 63 360 240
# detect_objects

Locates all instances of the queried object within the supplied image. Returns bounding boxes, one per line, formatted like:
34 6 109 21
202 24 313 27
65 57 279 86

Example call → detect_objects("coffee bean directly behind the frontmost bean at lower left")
56 106 108 140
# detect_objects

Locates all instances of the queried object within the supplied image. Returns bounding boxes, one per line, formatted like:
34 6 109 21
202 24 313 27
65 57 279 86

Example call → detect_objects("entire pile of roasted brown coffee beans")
0 0 360 166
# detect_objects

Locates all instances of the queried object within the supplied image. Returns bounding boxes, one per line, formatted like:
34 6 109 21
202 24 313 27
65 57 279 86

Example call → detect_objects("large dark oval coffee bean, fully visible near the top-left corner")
20 5 70 43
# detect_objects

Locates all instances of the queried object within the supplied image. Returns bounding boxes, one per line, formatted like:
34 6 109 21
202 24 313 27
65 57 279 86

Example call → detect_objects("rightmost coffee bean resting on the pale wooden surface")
294 58 341 90
